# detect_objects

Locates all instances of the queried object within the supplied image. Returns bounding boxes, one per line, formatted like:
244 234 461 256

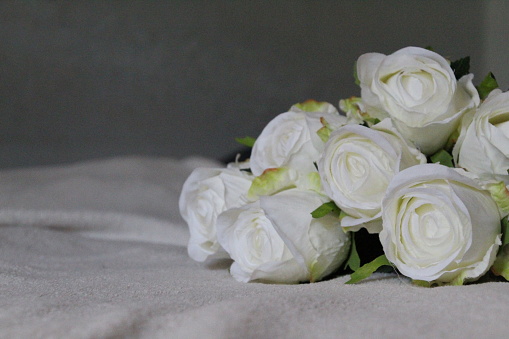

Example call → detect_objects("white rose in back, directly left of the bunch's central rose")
251 102 346 176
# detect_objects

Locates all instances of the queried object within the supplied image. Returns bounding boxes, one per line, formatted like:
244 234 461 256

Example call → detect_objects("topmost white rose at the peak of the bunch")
357 47 479 154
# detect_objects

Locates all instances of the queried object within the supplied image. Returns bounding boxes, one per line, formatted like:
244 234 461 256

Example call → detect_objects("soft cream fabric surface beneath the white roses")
0 157 509 338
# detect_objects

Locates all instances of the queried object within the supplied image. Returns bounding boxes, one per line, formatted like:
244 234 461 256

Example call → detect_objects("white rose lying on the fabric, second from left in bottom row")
217 189 350 283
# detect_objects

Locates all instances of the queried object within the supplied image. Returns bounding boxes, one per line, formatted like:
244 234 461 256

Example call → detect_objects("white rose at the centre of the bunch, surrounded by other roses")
318 119 426 233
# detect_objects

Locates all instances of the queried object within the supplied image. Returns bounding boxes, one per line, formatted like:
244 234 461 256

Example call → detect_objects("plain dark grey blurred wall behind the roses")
0 0 509 168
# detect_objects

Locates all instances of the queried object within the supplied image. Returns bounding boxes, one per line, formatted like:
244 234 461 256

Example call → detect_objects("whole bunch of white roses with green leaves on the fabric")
179 47 509 286
